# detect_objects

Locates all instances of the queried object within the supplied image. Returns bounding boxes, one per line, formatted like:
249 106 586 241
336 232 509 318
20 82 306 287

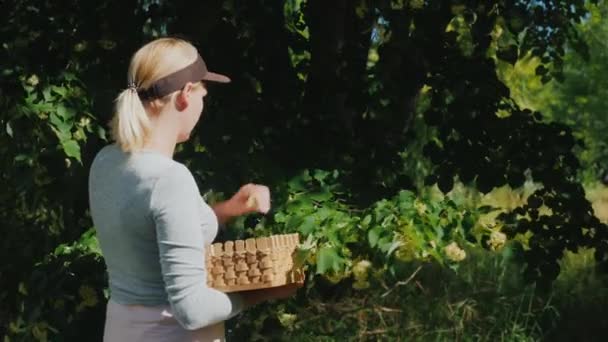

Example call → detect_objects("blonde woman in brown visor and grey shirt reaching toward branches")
89 38 296 342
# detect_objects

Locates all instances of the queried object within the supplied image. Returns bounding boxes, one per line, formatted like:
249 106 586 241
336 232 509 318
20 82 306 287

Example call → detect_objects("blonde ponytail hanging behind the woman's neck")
110 88 150 152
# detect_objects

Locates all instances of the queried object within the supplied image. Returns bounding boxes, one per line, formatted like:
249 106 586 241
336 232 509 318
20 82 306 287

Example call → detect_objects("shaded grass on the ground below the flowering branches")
232 246 608 341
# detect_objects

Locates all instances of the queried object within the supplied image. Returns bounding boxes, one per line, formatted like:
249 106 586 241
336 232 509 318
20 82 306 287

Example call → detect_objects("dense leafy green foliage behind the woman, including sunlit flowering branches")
0 0 608 341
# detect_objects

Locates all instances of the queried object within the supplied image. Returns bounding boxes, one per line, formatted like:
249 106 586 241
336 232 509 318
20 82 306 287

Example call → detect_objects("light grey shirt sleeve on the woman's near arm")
150 163 243 330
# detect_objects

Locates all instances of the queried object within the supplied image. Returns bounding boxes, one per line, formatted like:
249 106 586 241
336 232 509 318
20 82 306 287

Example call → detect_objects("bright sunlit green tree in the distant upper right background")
502 1 608 183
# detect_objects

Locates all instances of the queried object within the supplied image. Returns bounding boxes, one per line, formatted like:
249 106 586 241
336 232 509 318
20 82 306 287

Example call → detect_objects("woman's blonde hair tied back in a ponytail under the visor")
110 38 198 152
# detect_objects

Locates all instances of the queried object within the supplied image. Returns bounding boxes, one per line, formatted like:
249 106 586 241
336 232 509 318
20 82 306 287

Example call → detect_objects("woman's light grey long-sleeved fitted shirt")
89 145 243 330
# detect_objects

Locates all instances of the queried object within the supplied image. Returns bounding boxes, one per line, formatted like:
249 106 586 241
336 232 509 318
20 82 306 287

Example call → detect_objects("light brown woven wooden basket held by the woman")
206 234 304 292
